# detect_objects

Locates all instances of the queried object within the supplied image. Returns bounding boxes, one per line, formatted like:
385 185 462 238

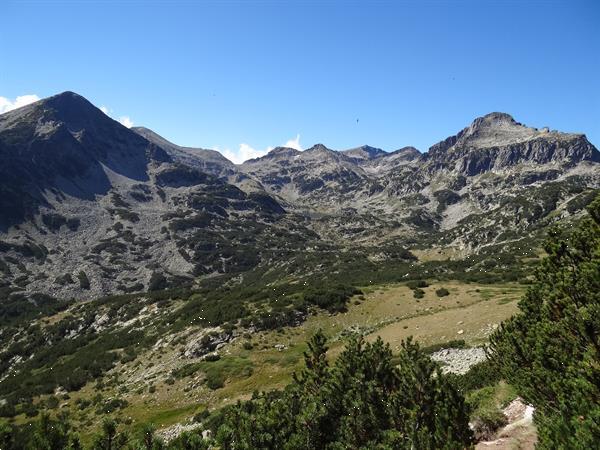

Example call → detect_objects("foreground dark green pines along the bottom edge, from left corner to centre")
0 331 472 450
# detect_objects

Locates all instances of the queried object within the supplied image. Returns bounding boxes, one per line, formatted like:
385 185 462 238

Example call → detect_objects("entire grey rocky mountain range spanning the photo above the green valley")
0 92 600 298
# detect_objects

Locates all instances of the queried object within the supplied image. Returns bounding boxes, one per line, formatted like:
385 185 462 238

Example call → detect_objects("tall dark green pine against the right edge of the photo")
491 192 600 448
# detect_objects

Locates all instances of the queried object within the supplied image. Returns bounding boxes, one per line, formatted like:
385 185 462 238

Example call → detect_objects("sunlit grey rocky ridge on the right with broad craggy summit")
240 113 600 244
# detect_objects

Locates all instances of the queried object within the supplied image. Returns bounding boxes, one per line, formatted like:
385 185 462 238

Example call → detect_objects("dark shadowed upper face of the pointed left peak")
0 92 170 230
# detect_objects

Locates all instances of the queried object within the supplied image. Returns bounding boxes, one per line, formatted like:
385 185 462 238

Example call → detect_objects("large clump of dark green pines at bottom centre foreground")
213 333 471 449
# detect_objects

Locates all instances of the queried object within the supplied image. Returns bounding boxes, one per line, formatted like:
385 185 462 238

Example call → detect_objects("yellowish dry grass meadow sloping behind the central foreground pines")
56 282 524 434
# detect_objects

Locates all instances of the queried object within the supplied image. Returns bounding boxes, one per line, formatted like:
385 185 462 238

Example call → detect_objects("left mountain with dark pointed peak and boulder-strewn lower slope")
0 92 311 298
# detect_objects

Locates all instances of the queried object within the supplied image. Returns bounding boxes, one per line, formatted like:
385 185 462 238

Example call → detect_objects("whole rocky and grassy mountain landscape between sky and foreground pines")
0 92 600 443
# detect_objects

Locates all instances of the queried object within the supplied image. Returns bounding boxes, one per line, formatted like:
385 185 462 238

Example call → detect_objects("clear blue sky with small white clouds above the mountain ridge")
0 0 600 159
